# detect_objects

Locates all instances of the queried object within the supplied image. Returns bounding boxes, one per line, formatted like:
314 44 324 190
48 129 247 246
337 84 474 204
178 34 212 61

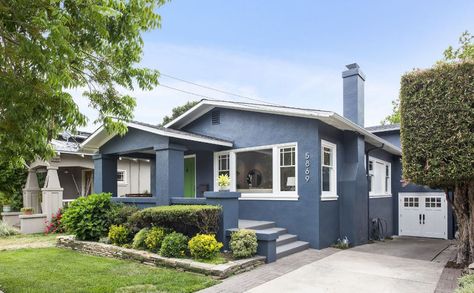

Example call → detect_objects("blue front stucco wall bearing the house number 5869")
184 109 320 247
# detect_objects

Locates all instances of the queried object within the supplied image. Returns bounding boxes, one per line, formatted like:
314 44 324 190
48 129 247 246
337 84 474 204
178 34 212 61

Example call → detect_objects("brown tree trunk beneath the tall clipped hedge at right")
453 183 474 265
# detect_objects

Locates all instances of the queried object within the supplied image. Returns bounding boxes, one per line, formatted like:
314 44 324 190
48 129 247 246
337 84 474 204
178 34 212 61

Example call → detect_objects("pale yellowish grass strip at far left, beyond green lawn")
0 233 61 250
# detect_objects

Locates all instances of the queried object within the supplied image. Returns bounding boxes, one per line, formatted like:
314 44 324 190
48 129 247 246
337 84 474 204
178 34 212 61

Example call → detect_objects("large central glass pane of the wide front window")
235 149 273 192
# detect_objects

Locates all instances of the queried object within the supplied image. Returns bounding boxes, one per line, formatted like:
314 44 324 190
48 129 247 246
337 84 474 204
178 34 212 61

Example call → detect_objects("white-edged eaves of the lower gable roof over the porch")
81 121 233 151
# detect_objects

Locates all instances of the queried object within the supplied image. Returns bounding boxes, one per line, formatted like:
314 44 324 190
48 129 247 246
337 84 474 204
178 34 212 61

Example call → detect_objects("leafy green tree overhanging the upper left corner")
0 0 165 164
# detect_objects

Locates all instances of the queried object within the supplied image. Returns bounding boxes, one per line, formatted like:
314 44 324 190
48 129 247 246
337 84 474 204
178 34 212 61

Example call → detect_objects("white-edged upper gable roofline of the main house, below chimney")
165 99 402 155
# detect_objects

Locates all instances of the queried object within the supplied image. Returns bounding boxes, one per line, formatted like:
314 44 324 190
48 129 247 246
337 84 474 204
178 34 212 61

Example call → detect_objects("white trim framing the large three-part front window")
214 142 299 201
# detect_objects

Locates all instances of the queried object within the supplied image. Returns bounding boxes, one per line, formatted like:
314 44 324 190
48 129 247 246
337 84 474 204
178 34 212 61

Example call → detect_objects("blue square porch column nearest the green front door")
155 145 185 205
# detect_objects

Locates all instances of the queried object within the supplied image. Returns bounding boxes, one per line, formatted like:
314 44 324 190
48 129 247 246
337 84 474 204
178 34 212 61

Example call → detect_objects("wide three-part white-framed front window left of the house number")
214 143 298 200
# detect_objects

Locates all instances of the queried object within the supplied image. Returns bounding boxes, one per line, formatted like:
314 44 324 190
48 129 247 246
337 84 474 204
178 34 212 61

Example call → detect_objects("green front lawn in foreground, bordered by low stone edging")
0 248 218 292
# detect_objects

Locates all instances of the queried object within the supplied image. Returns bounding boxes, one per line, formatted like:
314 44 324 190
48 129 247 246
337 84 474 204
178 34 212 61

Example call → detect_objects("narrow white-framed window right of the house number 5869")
321 140 338 200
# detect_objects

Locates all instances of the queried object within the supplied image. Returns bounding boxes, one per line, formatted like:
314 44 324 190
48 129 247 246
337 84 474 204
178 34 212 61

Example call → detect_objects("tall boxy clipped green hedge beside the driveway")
400 62 474 188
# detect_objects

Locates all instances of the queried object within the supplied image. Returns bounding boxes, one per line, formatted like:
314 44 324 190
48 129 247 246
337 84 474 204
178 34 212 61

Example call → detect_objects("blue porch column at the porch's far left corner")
92 154 117 197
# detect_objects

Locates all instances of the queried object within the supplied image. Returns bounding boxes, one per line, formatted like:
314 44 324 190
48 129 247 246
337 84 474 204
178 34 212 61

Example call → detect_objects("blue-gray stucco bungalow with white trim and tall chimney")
82 64 453 258
